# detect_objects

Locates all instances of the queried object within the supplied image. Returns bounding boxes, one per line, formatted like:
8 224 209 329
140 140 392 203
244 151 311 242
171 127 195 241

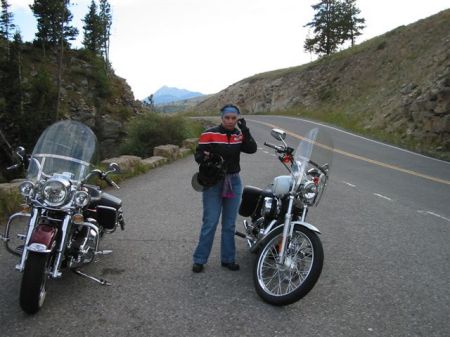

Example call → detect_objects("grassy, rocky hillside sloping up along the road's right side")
195 10 450 158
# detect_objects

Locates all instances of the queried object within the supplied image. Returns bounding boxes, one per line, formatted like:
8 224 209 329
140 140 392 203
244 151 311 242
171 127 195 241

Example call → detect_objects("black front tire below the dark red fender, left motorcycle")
20 252 50 314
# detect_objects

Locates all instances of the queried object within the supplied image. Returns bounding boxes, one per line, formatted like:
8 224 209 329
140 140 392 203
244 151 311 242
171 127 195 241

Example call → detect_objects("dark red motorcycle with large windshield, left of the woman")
0 120 125 314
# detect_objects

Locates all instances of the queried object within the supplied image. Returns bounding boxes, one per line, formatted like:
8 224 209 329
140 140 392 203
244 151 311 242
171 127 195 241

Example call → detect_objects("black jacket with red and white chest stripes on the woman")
195 124 257 174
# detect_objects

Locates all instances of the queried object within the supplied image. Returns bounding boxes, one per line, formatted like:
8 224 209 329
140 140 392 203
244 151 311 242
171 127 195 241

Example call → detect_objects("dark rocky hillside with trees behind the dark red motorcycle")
0 44 143 180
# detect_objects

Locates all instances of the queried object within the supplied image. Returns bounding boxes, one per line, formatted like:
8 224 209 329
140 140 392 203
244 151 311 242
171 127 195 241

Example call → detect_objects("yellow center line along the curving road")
249 119 450 185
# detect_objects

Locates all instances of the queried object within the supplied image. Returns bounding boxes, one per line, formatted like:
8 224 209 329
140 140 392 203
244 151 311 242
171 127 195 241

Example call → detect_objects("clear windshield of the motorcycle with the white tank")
293 128 334 205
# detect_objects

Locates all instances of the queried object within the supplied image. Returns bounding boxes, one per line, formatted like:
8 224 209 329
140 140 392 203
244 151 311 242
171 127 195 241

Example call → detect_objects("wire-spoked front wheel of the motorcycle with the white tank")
253 225 324 306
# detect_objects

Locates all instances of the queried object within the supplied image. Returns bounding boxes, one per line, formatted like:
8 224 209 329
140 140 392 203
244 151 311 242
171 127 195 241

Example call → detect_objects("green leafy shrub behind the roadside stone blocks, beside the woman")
120 113 203 158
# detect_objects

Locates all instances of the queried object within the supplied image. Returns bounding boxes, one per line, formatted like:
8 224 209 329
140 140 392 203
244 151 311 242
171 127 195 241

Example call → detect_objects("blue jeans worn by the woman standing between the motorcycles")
194 175 242 264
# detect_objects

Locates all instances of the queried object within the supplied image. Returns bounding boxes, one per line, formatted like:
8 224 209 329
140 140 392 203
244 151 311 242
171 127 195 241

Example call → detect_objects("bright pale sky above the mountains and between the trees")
9 0 450 99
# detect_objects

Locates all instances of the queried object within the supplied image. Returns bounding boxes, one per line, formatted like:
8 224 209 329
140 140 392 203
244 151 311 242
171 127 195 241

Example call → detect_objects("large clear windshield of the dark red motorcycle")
27 120 97 181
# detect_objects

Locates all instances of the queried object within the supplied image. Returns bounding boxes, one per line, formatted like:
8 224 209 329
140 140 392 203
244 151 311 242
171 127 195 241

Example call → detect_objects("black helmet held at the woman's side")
192 153 225 192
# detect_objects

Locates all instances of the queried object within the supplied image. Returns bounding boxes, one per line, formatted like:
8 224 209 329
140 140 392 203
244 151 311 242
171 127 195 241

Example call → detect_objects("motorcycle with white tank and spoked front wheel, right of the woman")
236 128 333 306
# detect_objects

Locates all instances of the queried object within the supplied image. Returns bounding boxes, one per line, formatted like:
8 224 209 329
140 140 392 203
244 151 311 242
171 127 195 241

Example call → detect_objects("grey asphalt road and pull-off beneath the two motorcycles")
0 116 450 337
